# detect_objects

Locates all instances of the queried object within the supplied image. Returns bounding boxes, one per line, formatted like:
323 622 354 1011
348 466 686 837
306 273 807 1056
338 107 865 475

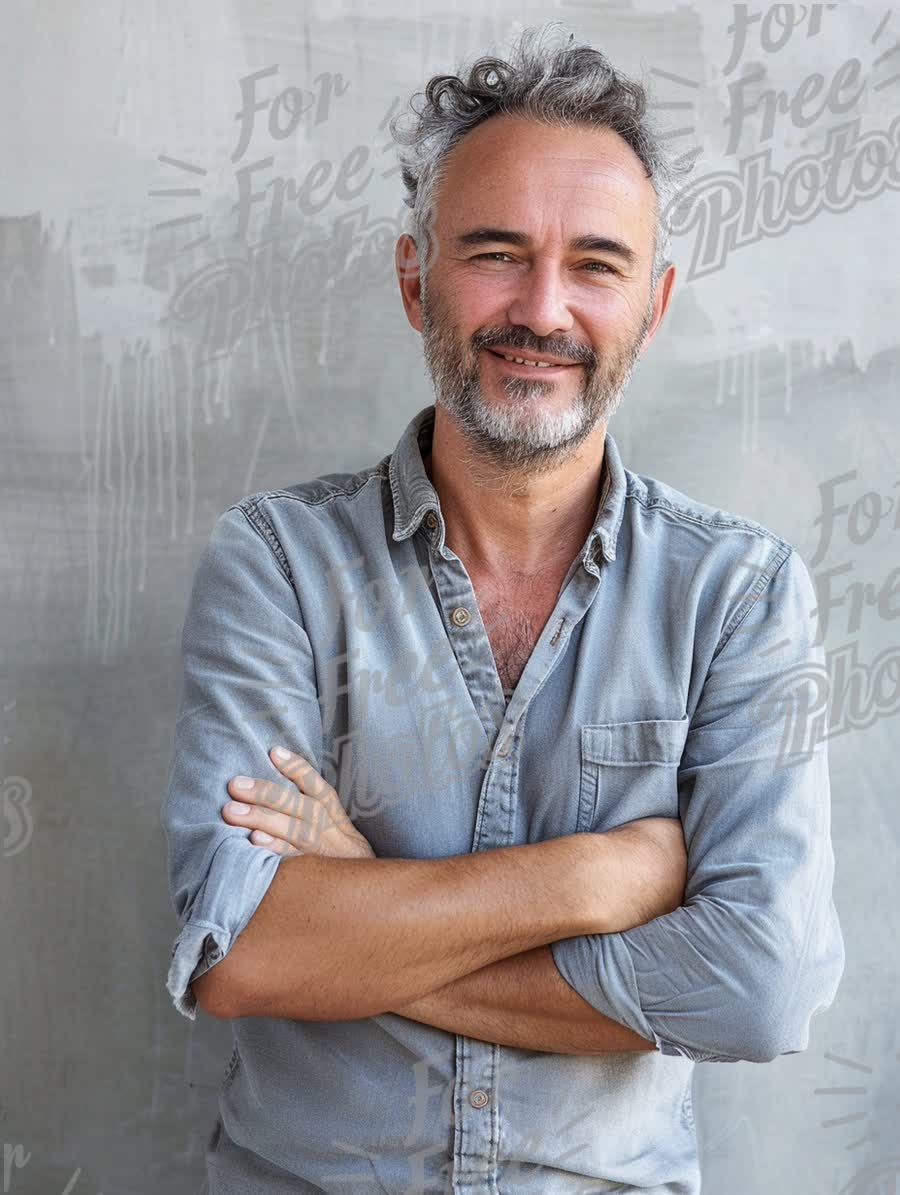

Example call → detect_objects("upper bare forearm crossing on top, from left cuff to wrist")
228 834 602 1021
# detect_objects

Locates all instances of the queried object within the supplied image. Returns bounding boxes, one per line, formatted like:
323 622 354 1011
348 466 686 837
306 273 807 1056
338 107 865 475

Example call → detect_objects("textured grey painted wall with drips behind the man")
0 0 900 1195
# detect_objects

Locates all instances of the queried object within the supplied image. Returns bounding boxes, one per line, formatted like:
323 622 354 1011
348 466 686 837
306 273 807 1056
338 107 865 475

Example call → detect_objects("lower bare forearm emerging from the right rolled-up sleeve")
391 946 656 1054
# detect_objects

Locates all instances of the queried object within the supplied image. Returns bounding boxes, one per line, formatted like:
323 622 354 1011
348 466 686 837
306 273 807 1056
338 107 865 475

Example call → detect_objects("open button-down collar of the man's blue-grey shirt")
388 403 626 565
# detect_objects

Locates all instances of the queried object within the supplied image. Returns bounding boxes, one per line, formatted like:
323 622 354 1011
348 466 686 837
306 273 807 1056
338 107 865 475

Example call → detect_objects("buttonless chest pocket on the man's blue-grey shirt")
576 715 690 833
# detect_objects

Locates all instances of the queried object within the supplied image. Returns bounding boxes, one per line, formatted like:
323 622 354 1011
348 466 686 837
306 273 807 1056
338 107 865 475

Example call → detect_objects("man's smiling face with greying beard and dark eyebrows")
411 115 656 472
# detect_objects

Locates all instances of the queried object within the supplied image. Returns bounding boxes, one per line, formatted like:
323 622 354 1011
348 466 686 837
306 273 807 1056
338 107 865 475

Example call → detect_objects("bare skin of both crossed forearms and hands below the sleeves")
194 756 684 1054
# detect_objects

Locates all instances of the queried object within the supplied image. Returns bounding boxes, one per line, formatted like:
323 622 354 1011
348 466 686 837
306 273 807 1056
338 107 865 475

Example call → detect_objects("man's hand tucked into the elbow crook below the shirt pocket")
596 817 687 933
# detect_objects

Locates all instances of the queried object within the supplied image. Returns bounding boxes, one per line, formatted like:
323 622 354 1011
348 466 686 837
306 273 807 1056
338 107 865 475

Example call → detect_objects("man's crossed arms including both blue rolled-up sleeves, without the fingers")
164 505 844 1062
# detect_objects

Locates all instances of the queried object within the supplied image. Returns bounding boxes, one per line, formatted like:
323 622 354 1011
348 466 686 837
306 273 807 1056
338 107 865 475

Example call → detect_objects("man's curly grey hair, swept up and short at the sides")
390 20 694 289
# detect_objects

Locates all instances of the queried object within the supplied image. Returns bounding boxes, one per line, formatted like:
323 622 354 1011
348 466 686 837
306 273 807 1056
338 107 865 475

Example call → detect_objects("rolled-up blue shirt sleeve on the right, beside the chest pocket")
551 549 844 1062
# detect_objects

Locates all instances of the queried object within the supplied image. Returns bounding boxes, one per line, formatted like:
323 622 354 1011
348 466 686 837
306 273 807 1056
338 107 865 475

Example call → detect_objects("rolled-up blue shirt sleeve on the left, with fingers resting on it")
163 498 322 1019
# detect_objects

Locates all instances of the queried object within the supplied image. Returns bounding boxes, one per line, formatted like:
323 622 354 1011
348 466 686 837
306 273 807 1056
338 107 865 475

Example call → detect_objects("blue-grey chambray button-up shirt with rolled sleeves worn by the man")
163 406 844 1195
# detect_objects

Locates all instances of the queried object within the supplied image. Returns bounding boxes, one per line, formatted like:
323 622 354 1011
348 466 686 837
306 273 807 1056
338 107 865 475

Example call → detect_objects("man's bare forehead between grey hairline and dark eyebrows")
436 112 656 248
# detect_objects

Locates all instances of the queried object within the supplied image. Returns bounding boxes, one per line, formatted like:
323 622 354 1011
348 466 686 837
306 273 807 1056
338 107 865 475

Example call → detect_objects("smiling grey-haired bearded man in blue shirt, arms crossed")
165 21 844 1195
